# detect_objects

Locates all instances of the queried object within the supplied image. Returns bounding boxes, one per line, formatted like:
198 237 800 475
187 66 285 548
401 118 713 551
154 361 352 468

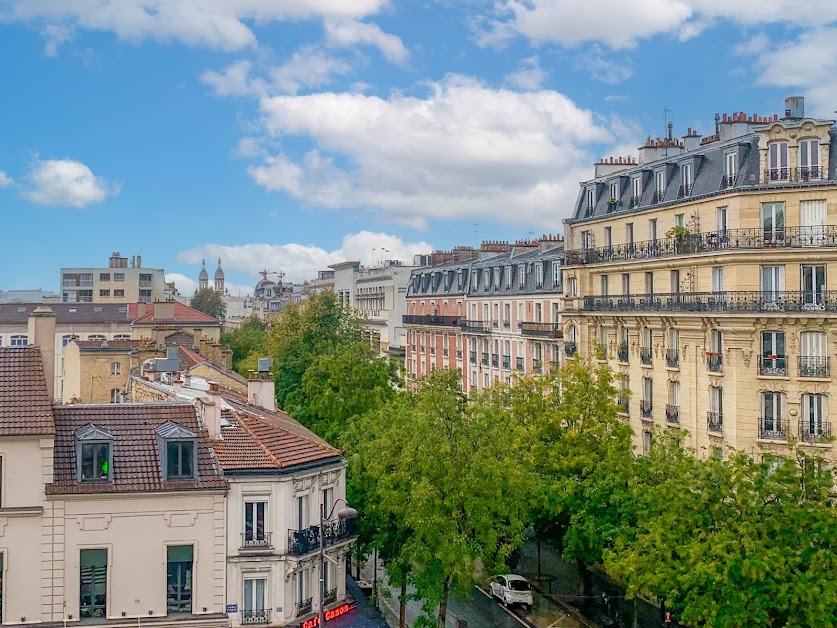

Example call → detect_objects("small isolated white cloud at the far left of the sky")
23 159 121 208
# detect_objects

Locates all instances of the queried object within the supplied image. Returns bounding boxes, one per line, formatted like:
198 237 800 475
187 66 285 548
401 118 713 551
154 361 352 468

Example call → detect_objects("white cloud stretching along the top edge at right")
473 0 837 49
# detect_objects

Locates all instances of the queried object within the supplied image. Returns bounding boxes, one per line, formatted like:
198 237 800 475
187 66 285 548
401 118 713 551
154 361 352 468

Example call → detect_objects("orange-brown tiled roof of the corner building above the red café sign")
212 395 341 471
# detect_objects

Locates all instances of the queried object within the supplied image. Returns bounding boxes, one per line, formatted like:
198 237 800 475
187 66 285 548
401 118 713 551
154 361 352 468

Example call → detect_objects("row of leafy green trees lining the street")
224 293 837 626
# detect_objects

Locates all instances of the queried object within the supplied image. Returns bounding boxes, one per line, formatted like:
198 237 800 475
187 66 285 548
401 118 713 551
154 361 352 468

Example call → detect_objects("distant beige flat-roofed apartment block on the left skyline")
60 252 166 303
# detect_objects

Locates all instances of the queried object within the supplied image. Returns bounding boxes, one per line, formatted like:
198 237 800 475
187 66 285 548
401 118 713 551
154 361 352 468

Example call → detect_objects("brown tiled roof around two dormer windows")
46 403 227 495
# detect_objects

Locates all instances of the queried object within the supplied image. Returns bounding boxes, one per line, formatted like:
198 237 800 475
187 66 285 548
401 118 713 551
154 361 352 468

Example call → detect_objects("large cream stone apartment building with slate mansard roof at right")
563 98 837 461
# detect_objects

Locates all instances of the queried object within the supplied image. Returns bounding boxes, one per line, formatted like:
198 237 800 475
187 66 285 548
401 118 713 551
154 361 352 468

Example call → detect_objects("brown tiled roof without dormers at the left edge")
0 347 55 436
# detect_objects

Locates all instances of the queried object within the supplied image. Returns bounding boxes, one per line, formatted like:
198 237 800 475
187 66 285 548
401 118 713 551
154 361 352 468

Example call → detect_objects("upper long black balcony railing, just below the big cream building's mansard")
565 225 837 266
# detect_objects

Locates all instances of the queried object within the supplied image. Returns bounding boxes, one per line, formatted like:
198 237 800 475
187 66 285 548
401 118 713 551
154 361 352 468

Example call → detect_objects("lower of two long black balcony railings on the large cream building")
583 290 837 313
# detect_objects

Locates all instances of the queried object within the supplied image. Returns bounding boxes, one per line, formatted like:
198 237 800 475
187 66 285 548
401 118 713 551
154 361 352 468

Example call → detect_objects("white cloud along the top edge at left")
6 0 388 50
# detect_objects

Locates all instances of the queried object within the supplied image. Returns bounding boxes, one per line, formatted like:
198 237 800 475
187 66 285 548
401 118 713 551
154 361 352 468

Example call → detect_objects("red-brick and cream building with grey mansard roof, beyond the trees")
404 236 564 391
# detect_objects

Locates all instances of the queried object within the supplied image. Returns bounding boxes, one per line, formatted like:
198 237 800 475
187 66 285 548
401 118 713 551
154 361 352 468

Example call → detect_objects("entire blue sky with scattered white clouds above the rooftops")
0 0 837 292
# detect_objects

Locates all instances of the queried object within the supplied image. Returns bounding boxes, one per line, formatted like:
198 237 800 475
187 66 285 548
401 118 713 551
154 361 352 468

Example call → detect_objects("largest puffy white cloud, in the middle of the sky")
243 76 617 229
